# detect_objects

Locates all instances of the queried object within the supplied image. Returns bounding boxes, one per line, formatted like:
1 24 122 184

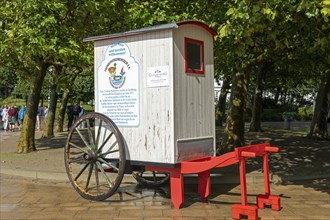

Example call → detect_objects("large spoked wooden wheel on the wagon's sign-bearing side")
64 112 126 201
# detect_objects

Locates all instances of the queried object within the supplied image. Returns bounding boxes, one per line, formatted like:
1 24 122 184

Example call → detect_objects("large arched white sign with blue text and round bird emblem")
95 42 140 127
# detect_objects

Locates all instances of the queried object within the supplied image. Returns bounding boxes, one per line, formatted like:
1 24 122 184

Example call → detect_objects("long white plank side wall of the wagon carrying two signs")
94 30 174 164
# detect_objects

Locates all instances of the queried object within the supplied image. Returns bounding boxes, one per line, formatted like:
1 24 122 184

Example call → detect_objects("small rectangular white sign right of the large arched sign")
147 66 170 87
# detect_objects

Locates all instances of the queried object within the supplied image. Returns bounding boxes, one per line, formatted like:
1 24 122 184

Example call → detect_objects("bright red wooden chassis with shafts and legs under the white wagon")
146 143 281 220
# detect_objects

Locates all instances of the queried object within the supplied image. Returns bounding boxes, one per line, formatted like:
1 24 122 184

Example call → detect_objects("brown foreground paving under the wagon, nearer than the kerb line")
0 174 330 220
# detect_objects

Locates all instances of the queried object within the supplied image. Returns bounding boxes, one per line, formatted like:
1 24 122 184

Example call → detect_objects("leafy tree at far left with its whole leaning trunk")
0 0 90 152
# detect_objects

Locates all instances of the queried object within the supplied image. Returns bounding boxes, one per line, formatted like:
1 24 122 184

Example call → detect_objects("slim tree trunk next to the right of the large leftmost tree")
42 77 57 138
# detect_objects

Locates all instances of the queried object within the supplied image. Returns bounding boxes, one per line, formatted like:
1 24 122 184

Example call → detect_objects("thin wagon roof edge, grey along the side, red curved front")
83 21 217 42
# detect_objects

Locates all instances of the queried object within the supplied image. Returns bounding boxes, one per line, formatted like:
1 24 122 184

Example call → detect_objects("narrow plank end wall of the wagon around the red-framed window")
173 25 215 160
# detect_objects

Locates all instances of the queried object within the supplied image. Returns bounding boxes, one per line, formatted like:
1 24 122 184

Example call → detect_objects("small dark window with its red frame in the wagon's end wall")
184 38 204 74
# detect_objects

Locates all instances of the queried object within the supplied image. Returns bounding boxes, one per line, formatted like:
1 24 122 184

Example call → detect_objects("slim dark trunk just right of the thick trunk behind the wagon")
250 62 269 132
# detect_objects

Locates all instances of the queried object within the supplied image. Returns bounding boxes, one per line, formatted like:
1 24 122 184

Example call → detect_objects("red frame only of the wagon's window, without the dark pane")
184 37 204 74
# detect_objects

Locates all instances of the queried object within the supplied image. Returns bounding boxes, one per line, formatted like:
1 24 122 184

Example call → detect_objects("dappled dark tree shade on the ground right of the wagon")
217 122 330 194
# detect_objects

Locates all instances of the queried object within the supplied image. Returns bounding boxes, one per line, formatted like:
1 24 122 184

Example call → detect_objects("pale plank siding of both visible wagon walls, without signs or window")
94 24 215 166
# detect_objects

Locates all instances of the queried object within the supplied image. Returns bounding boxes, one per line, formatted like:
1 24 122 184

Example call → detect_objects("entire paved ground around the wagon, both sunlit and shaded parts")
0 122 330 220
